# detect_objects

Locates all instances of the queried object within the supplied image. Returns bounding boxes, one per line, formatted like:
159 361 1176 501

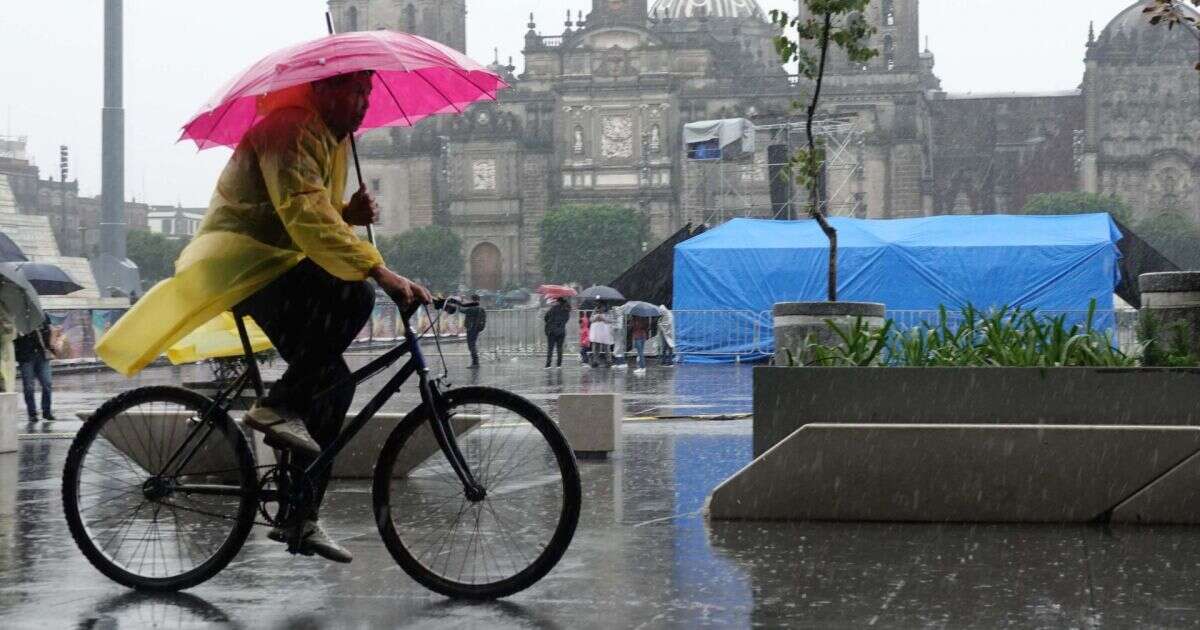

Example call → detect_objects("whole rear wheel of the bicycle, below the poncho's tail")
62 388 257 592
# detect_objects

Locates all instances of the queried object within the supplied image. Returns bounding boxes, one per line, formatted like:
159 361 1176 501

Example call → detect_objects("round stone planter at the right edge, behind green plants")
1138 271 1200 364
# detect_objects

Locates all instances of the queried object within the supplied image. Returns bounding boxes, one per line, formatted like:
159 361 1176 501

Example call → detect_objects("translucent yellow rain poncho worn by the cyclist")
96 86 383 376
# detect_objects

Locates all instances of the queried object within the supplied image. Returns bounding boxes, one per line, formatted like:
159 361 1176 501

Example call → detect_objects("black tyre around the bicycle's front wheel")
372 388 582 600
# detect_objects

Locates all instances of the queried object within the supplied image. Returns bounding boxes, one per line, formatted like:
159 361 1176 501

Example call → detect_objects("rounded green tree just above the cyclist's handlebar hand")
378 226 466 292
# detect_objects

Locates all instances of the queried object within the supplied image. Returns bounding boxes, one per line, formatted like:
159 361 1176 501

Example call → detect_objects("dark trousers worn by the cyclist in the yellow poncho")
234 259 374 518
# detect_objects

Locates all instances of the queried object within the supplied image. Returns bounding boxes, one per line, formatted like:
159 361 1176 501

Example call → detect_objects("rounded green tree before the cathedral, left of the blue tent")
541 205 647 284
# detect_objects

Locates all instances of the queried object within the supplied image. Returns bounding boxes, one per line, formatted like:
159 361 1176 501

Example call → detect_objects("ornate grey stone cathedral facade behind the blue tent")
329 0 1200 288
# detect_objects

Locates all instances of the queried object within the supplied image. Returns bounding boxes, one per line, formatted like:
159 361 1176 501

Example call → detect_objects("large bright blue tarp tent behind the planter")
674 214 1121 361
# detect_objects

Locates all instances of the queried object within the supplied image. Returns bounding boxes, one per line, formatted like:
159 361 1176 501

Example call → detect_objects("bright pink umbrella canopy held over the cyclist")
180 30 508 149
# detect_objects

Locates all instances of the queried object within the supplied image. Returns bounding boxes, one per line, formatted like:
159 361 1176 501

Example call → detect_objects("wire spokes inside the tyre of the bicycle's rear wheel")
68 388 257 580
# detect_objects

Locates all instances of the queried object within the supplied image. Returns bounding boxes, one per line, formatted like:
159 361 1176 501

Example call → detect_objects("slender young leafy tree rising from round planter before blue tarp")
770 0 878 302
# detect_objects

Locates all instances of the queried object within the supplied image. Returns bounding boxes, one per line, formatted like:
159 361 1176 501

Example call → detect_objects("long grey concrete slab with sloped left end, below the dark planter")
708 424 1200 522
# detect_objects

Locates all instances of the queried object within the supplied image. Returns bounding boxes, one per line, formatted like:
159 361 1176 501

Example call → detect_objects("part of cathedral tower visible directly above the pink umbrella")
329 0 467 50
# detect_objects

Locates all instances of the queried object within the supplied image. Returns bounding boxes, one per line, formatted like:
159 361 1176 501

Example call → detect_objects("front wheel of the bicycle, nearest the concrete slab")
373 388 582 599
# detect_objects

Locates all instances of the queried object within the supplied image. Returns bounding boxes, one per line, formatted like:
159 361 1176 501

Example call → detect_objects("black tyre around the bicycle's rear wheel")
62 386 257 593
